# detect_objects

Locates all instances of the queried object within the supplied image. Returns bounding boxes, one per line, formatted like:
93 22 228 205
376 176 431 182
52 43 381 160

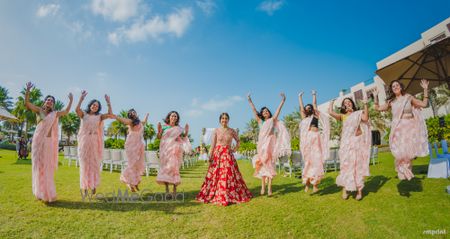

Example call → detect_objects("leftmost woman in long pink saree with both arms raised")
25 82 73 202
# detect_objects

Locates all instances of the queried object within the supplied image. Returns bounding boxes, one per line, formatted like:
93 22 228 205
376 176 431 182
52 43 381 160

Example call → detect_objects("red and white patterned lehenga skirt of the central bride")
197 145 252 206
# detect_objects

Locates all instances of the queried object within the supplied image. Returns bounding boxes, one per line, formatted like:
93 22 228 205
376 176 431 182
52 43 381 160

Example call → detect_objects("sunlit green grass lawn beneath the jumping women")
0 150 450 238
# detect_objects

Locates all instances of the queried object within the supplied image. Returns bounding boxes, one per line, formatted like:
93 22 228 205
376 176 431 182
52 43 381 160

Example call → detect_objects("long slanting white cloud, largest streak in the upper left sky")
108 8 194 45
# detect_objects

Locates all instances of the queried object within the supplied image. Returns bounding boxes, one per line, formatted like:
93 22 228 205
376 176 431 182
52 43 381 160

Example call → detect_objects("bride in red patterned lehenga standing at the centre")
197 113 252 206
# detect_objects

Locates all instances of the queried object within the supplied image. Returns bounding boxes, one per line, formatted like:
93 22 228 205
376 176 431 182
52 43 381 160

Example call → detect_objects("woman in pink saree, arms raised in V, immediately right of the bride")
247 93 291 196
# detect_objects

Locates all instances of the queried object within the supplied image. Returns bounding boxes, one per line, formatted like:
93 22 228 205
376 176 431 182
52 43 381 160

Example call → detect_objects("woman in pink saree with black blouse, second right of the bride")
298 91 330 192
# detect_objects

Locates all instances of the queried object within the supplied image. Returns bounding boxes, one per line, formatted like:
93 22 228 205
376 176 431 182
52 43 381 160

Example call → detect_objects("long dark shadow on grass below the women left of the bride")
47 191 203 215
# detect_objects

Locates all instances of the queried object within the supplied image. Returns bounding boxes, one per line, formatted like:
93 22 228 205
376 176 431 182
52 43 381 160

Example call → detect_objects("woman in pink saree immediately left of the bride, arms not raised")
156 111 191 196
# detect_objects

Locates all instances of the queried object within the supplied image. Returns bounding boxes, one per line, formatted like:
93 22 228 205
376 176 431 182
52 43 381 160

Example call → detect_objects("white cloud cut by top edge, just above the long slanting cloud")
91 0 140 22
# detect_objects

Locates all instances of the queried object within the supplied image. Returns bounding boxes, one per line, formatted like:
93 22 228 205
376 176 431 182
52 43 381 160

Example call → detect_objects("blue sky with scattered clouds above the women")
0 0 450 144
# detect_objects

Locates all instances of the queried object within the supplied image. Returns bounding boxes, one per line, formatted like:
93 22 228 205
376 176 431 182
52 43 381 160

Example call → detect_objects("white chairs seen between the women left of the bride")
64 146 197 176
